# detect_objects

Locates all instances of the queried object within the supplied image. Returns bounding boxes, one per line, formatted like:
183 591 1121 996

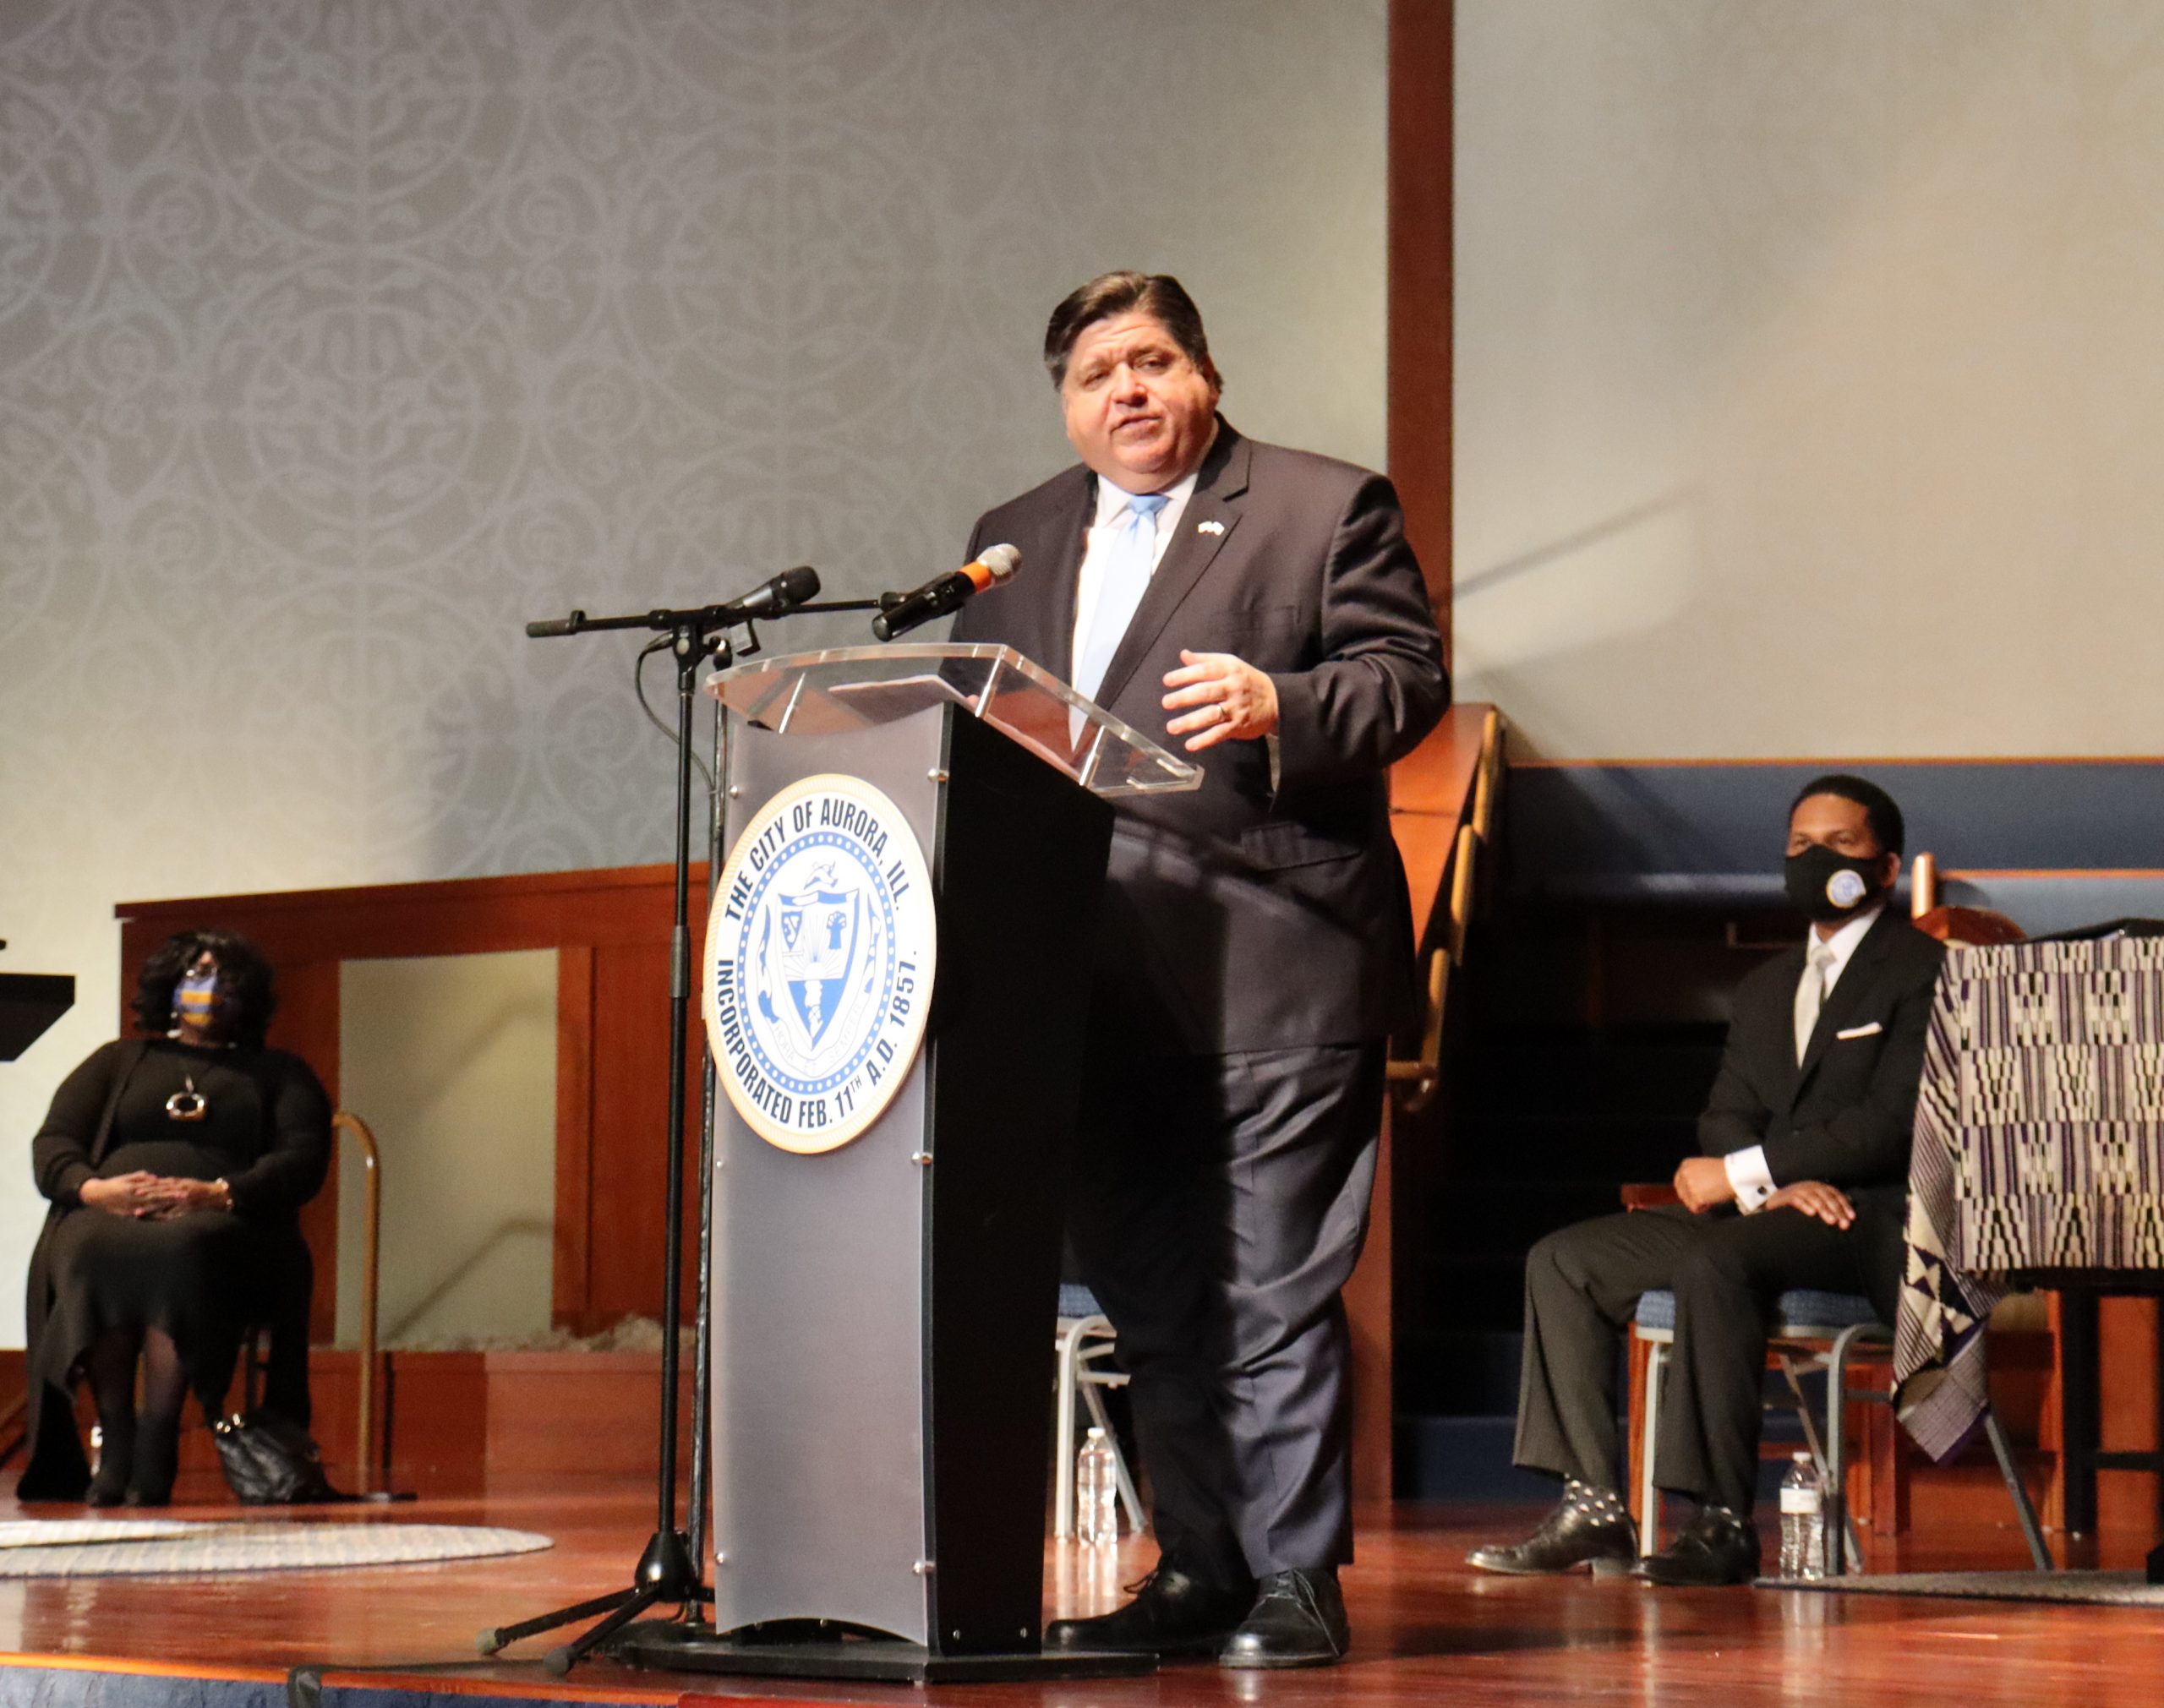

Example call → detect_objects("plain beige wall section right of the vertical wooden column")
1452 0 2164 757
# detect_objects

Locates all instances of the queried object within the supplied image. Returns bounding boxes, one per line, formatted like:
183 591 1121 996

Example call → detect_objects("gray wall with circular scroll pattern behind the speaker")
0 0 1385 1335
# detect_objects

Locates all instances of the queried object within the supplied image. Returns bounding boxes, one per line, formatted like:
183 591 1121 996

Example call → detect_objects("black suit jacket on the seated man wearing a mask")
1699 905 1945 1195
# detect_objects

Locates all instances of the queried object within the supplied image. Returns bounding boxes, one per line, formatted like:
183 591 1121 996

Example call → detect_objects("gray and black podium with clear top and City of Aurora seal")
631 645 1201 1680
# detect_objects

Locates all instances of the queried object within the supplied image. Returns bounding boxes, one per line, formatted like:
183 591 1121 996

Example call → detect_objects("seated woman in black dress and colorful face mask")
15 930 331 1507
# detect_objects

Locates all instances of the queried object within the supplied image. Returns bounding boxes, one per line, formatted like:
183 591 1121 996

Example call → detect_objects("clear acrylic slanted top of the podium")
706 645 1203 797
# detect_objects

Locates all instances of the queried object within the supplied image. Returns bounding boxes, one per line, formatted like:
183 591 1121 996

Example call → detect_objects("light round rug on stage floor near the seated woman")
0 1518 554 1578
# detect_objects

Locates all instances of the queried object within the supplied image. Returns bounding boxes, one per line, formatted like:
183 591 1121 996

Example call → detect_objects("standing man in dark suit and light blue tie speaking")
954 273 1450 1667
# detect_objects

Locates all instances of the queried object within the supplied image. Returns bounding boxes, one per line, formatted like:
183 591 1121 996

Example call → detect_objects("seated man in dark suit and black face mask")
1469 775 1945 1585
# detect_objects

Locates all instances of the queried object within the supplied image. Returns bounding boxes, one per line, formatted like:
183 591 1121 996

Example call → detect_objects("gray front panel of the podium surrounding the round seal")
708 714 943 1643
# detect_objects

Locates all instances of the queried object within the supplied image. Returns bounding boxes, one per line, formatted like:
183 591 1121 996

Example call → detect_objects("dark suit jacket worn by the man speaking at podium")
954 422 1450 1054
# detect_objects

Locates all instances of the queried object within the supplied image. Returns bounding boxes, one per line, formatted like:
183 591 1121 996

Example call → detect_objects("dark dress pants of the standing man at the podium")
1069 1044 1383 1585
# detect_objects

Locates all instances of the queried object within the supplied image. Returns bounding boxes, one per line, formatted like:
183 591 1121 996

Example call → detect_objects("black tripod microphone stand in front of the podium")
474 604 805 1678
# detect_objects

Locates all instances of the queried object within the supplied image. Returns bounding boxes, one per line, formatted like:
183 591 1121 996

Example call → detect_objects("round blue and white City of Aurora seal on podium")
706 775 937 1152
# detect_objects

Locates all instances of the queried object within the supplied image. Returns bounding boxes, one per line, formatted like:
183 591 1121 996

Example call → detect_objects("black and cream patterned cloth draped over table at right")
1894 937 2164 1459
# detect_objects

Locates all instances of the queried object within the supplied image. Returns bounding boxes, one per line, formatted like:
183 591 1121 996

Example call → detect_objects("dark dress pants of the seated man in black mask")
1512 1187 1906 1513
